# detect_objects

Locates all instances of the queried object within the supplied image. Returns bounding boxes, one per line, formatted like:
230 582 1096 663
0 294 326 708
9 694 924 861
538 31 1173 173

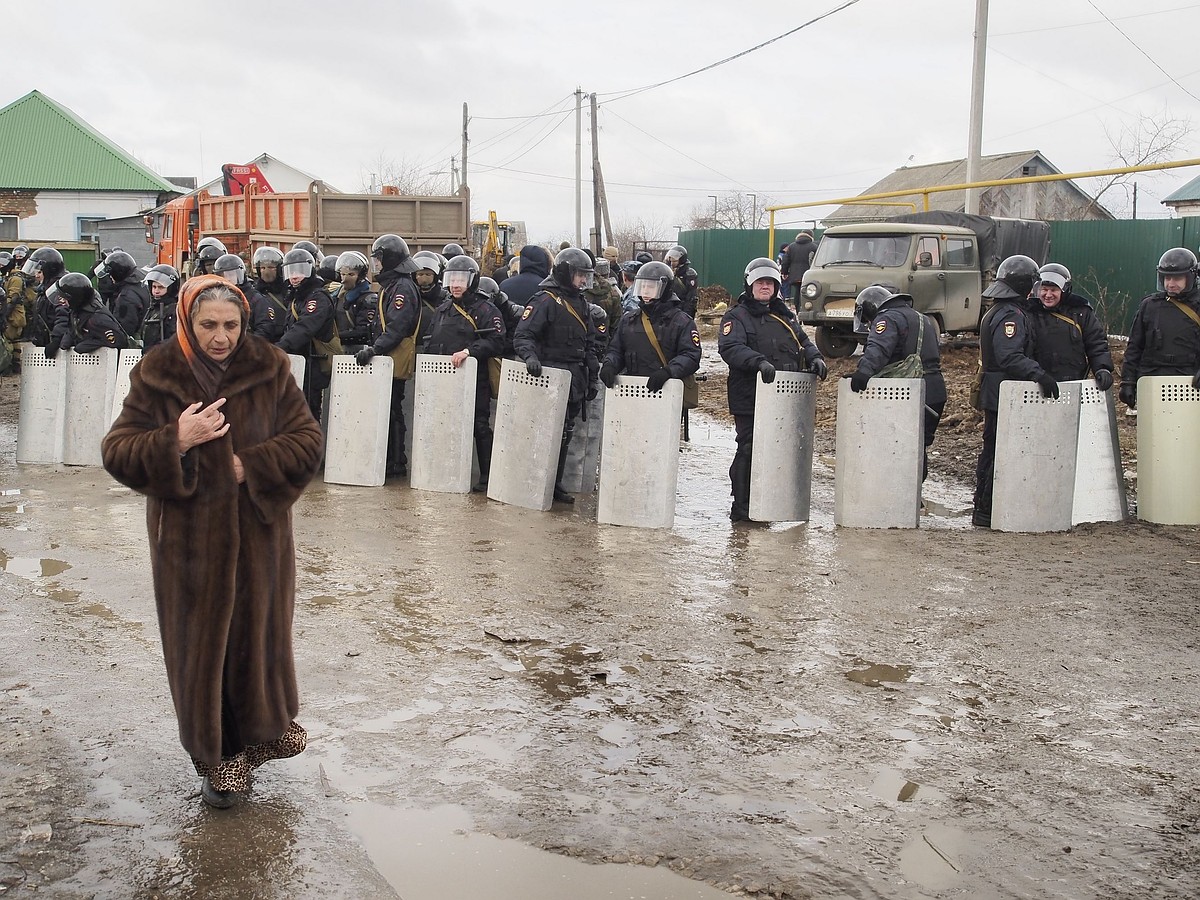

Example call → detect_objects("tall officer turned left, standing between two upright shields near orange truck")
355 234 424 475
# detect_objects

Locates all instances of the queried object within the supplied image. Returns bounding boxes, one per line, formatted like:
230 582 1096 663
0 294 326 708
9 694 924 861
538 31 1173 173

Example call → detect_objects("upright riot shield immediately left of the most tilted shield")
408 353 479 493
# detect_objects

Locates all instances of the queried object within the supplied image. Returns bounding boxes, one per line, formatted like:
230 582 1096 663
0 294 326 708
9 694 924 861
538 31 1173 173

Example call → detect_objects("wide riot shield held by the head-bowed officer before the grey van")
835 378 925 528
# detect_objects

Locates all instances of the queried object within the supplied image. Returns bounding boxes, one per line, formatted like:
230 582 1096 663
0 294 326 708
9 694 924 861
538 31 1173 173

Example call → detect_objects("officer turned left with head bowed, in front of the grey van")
850 284 946 481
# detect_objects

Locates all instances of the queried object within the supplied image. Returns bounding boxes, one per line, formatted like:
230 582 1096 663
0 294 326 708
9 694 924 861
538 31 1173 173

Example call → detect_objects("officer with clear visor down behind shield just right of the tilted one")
600 263 700 392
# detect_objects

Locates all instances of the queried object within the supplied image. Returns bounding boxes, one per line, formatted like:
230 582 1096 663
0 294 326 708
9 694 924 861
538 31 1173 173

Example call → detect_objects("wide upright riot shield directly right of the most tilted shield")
596 376 683 528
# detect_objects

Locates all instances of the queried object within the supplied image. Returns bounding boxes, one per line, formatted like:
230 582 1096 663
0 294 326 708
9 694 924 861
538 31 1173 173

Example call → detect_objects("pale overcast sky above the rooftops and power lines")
9 0 1200 241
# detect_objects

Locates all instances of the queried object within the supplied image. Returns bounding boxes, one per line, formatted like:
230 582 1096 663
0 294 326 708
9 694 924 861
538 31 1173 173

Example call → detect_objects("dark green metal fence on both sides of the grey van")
679 217 1200 334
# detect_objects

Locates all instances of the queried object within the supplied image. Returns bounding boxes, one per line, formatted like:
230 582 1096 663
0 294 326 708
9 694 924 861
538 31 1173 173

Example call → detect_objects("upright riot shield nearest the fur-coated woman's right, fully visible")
325 356 391 487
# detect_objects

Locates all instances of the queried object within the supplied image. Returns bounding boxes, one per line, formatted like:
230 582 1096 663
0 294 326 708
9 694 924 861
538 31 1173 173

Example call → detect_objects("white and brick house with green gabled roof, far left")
0 90 182 245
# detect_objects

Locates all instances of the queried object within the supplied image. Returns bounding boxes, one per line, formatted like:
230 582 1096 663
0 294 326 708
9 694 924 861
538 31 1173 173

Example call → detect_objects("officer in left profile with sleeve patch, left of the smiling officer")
971 256 1058 528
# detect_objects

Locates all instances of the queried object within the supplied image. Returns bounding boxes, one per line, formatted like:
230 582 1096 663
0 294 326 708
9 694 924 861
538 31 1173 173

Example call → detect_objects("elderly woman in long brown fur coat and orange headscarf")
103 276 322 808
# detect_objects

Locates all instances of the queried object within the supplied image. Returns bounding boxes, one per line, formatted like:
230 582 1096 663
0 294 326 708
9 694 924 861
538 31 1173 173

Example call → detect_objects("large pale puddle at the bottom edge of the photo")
349 803 730 900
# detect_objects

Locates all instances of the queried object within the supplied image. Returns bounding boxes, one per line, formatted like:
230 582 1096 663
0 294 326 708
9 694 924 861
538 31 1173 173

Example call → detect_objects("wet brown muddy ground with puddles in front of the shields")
0 346 1200 900
